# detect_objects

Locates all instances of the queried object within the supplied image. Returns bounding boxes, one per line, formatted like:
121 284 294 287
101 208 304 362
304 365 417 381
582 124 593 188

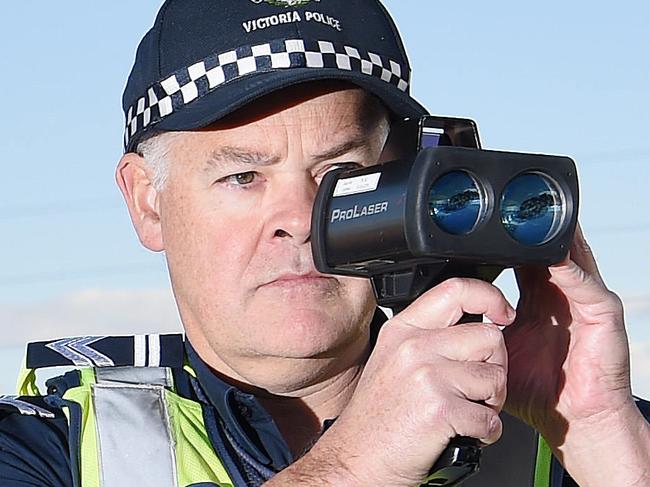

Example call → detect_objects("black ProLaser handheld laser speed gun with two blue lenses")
312 116 578 486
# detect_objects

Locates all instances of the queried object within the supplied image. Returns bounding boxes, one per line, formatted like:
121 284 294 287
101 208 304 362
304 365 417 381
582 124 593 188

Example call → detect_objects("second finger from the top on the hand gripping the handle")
422 323 508 370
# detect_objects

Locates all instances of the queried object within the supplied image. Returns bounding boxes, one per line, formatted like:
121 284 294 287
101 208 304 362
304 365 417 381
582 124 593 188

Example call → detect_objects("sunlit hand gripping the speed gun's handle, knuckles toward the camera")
310 279 514 486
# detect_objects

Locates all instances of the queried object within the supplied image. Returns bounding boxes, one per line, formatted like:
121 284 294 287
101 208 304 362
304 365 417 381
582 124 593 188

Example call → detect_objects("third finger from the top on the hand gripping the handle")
445 361 508 412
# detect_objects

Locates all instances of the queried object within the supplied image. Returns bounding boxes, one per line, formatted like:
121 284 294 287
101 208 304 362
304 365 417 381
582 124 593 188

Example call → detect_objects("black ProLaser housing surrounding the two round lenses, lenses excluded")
312 147 578 277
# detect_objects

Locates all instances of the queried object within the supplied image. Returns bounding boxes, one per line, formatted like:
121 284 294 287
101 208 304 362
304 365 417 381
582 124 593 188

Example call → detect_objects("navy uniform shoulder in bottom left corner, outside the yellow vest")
0 396 72 487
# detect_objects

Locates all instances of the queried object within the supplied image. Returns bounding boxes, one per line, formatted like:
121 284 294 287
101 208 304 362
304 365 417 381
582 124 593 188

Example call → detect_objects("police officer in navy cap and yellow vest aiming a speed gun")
0 0 650 487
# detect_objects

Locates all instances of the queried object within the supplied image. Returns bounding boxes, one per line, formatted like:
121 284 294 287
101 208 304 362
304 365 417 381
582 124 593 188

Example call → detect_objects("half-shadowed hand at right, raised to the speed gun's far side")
504 227 633 448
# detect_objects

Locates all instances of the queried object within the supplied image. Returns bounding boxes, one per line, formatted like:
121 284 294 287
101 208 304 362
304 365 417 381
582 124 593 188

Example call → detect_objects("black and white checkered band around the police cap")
124 39 410 147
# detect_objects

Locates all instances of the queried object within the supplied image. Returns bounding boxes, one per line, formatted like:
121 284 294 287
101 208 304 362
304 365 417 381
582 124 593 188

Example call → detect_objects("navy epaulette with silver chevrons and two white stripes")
26 333 185 369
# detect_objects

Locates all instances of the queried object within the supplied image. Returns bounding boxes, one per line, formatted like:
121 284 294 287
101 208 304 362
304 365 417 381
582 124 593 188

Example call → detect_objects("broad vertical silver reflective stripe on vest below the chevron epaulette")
92 386 178 487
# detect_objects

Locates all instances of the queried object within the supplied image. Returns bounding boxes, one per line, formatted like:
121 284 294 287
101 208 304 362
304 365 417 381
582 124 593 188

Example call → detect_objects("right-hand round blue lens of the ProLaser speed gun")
501 173 565 246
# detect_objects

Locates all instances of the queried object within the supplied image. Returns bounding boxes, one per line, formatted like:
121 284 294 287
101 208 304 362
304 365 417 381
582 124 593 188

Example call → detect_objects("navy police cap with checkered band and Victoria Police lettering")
122 0 426 152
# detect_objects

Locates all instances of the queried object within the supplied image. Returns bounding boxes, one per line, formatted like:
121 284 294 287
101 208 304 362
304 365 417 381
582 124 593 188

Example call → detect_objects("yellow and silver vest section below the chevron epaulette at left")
18 339 234 487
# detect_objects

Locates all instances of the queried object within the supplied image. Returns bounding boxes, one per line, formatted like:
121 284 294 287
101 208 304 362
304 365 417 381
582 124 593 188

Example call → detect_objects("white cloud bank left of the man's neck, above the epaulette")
0 289 181 348
